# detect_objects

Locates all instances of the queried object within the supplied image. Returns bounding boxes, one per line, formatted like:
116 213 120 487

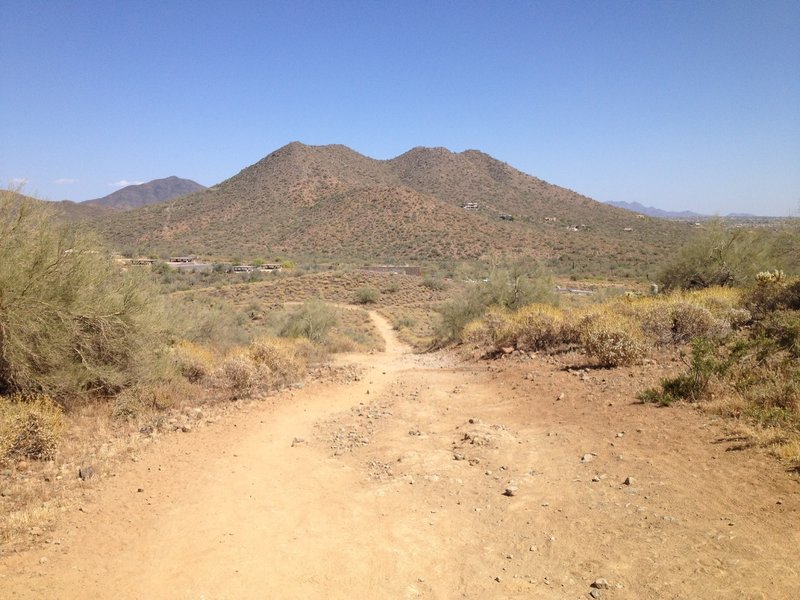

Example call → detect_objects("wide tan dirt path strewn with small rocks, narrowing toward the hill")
0 315 800 600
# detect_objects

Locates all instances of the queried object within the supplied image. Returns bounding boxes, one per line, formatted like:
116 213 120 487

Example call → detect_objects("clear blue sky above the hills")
0 0 800 216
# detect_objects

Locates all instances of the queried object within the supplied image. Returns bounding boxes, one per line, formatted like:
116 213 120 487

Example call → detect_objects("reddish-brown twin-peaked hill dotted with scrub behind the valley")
86 142 688 275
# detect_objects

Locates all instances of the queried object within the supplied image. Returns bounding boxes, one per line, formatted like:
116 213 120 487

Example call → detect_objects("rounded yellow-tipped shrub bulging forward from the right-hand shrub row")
580 312 645 367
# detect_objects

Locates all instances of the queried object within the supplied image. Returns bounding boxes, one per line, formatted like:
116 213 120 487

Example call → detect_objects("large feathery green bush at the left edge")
0 192 164 400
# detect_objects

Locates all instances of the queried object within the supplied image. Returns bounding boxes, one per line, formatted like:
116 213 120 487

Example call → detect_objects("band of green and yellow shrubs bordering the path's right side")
446 223 800 468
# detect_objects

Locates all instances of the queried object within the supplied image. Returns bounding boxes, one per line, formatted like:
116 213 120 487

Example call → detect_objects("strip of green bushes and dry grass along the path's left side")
0 191 382 542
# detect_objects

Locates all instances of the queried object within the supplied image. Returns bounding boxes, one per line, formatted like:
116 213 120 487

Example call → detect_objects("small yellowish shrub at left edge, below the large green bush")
0 394 64 460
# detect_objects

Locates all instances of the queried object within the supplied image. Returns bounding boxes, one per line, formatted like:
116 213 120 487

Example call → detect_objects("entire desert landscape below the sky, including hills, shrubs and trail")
0 142 800 600
